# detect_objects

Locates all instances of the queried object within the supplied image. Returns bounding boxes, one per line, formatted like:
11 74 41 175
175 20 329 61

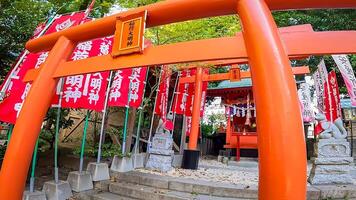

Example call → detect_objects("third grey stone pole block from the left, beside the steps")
67 171 94 192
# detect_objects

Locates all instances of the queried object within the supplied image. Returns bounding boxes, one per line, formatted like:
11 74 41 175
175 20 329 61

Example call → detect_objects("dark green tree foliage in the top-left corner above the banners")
0 0 115 80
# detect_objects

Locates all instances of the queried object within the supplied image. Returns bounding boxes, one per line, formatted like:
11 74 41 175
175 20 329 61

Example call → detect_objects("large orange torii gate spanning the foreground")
0 0 356 200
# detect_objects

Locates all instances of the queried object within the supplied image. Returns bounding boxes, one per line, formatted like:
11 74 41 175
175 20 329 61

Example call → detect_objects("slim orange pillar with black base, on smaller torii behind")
182 67 203 169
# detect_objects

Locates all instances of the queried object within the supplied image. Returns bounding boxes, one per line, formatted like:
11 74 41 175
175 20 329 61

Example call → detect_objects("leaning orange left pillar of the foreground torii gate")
0 36 75 200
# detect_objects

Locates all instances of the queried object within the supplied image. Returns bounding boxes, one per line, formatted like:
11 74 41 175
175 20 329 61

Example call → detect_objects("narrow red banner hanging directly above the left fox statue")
155 66 171 121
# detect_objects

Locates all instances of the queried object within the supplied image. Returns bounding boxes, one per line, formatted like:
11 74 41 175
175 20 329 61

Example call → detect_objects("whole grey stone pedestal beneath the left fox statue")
146 133 174 172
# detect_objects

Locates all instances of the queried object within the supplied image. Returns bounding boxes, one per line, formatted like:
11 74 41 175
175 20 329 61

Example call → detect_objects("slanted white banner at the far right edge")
332 55 356 106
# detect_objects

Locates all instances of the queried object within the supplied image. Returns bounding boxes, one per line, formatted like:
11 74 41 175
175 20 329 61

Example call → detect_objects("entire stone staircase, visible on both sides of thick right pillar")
74 171 356 200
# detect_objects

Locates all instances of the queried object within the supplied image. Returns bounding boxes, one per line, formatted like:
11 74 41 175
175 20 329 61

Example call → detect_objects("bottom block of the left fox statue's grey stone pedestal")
146 154 173 172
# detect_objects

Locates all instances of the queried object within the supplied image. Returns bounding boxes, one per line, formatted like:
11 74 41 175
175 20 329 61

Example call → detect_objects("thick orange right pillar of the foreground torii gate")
237 0 307 200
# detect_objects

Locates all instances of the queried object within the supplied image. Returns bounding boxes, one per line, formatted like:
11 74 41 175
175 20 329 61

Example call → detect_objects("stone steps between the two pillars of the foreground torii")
81 172 257 200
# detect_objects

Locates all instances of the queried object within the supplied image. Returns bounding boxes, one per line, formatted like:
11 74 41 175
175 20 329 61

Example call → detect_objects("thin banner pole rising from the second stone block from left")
54 79 64 183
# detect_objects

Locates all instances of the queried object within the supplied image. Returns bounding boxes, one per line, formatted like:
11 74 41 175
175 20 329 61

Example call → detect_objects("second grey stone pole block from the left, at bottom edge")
42 181 73 200
